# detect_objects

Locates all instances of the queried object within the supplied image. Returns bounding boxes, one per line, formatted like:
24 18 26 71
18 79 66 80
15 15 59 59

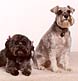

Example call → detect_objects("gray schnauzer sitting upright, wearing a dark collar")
34 6 75 72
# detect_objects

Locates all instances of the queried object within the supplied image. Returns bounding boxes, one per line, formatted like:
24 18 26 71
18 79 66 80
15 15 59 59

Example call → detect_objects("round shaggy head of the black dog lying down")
5 34 34 58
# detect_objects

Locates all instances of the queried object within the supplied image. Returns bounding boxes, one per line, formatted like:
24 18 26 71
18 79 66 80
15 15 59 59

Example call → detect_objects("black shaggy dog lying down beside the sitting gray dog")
0 34 34 76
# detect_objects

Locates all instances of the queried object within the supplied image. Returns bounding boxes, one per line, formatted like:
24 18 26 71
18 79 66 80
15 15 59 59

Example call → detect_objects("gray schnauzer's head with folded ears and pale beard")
51 6 75 28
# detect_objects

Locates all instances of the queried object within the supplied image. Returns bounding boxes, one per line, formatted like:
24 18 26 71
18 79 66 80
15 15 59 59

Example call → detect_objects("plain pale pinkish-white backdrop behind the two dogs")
0 0 78 51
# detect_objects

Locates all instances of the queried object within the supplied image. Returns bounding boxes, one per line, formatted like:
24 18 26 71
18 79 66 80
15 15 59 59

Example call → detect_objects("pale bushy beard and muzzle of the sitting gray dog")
56 16 74 28
